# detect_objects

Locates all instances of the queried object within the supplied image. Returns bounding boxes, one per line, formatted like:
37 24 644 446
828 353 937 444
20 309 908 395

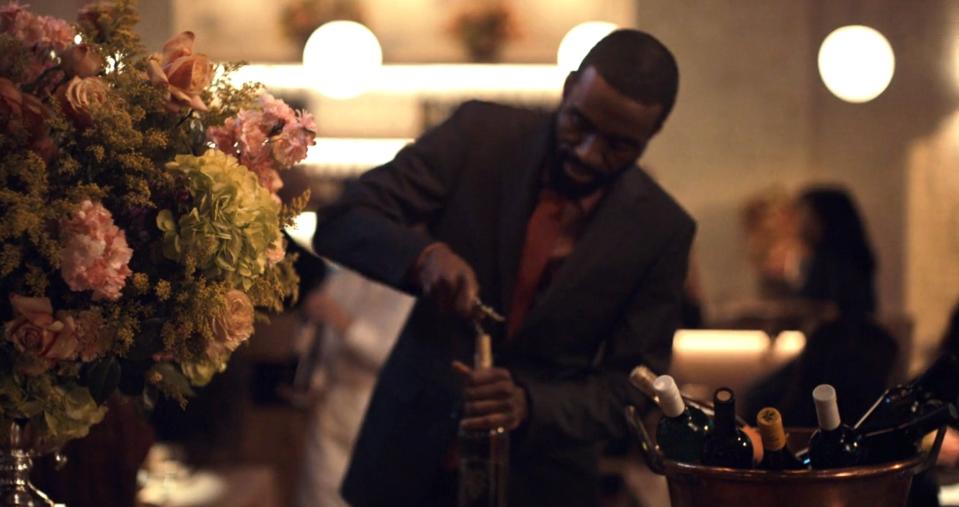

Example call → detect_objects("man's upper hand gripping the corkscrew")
413 243 479 319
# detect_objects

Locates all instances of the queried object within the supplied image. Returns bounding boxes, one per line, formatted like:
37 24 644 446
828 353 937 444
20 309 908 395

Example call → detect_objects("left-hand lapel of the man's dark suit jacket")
498 121 553 322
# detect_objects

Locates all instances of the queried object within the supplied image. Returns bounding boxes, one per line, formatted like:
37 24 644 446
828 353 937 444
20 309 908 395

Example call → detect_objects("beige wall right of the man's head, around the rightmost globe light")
637 0 959 368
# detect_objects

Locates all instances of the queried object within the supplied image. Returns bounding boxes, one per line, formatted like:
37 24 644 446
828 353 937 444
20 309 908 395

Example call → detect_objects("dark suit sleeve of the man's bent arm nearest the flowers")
313 105 469 287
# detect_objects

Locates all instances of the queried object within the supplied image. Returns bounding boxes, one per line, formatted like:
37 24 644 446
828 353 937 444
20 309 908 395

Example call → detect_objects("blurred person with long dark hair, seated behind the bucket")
743 186 898 427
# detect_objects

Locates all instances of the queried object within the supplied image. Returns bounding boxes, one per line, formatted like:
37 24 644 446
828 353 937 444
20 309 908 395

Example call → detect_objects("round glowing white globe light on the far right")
819 25 896 103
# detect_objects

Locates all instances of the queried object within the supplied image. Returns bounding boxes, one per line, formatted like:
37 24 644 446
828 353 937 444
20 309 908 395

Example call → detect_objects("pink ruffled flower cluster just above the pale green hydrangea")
207 93 316 194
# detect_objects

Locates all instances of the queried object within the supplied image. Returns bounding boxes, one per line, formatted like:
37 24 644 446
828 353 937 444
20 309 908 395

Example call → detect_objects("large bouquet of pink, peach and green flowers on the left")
0 0 316 448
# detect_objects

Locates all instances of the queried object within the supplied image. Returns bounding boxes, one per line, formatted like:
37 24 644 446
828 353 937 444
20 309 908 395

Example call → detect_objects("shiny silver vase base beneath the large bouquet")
0 422 62 507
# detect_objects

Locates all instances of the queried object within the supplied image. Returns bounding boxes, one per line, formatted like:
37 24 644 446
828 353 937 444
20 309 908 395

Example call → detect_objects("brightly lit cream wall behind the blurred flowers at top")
172 0 635 63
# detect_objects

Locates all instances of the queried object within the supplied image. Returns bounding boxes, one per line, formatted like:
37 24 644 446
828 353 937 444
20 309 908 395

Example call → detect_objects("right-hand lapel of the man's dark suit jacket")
516 167 648 341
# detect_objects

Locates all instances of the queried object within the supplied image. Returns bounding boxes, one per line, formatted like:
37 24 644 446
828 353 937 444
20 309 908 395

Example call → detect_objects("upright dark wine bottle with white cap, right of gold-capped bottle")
809 384 863 469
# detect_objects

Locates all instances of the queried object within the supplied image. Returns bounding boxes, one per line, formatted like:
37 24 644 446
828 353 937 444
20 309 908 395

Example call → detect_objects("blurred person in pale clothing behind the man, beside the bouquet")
296 266 414 507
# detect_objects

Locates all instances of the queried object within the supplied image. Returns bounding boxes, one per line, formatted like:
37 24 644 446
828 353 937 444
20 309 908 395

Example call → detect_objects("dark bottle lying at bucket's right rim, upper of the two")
854 352 959 433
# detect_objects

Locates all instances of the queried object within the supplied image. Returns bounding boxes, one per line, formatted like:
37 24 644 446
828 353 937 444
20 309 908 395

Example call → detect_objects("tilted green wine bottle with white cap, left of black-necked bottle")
653 375 711 463
